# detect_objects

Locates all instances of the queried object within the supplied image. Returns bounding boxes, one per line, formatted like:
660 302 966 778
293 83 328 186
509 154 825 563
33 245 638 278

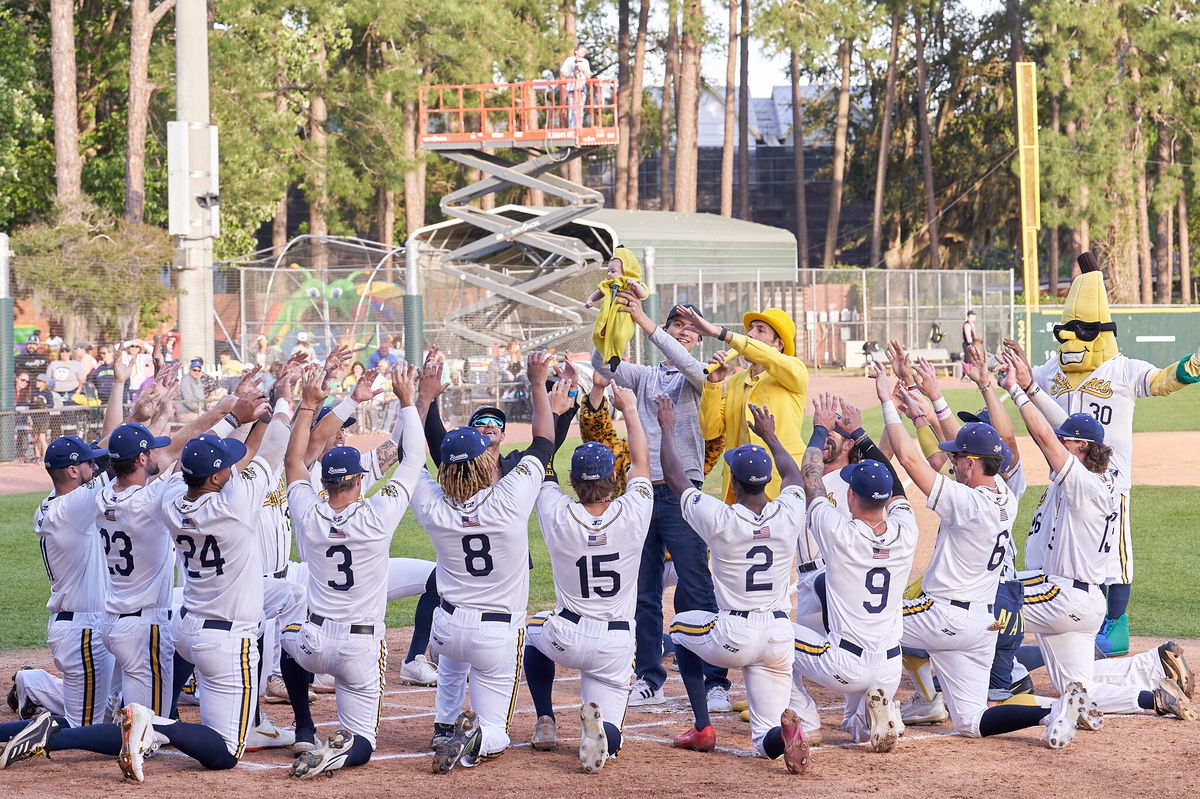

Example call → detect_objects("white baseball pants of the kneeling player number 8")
430 601 524 756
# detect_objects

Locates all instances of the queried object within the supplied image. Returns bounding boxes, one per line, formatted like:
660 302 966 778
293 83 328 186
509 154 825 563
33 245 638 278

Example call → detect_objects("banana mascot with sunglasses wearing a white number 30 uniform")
1026 252 1200 655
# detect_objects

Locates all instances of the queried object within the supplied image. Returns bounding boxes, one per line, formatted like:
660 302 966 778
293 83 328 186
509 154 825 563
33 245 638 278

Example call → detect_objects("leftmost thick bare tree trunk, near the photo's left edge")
50 0 83 216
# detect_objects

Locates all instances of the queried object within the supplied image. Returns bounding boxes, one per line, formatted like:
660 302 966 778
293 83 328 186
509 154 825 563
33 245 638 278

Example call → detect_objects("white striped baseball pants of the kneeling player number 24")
174 613 259 759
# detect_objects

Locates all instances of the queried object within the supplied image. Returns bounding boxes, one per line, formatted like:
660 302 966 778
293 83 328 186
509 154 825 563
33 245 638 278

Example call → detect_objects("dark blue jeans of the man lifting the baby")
634 482 730 690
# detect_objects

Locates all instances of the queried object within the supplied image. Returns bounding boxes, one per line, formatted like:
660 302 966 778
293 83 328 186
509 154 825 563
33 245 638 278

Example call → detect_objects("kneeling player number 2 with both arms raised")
655 396 809 774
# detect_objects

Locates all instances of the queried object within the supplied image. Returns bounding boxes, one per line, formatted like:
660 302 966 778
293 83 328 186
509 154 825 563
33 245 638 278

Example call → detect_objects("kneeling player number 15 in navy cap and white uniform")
524 388 654 774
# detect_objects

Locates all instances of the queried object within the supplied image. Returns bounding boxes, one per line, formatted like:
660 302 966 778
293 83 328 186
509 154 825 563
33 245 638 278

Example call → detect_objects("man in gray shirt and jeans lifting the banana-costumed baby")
592 292 732 713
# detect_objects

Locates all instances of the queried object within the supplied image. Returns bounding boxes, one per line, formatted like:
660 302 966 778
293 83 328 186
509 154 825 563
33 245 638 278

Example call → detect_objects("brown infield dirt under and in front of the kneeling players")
0 630 1200 799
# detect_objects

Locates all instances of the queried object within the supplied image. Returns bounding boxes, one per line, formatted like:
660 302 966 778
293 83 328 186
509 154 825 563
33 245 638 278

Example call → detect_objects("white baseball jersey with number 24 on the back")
162 456 275 624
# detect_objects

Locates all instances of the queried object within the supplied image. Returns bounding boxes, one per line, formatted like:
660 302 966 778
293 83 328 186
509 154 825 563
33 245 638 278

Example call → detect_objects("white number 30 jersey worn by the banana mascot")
1033 354 1158 493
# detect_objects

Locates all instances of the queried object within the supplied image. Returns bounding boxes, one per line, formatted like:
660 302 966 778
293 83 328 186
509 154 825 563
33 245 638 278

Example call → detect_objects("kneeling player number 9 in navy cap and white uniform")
792 395 917 752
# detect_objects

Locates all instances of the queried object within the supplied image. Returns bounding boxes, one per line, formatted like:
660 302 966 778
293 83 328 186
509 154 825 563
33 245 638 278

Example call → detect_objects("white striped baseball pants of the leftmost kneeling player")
46 612 116 727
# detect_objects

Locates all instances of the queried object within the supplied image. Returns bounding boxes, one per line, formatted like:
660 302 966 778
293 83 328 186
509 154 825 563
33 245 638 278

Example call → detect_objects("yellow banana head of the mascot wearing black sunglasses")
1054 252 1120 373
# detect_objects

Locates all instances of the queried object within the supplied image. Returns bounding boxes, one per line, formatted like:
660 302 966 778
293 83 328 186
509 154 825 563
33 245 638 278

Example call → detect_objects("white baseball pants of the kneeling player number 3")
279 619 388 750
